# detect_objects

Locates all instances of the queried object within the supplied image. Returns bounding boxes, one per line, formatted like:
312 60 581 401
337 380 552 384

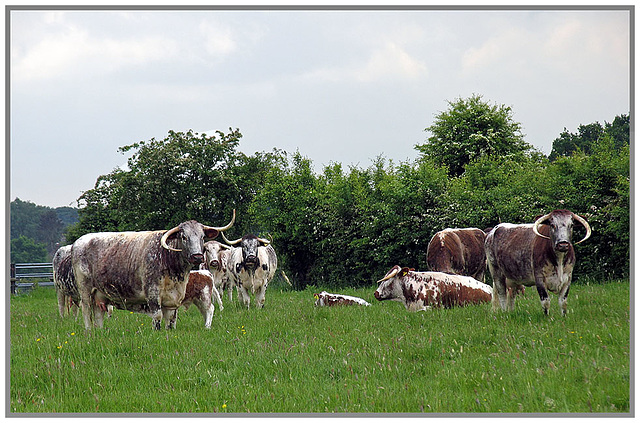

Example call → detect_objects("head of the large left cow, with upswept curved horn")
160 210 236 265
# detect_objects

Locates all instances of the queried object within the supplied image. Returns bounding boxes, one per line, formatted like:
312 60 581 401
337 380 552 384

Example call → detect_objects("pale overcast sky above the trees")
10 6 630 207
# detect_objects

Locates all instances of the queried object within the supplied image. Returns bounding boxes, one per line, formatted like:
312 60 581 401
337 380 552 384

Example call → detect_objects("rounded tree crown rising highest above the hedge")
415 95 533 176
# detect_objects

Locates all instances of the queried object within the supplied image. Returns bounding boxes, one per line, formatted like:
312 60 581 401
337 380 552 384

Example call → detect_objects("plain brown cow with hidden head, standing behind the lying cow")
427 228 486 282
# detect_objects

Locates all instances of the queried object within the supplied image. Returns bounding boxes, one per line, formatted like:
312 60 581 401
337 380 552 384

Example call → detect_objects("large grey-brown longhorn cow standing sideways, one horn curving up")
71 210 235 330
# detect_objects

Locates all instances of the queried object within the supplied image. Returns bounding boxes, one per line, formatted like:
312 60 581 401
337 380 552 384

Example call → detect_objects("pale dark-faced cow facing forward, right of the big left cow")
222 234 278 308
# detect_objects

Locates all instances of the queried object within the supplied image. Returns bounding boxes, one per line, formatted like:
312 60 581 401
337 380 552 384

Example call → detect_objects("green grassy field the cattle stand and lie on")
8 281 630 413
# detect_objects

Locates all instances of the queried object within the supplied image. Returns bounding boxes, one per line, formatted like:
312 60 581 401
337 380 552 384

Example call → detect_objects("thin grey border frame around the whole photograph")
5 5 635 419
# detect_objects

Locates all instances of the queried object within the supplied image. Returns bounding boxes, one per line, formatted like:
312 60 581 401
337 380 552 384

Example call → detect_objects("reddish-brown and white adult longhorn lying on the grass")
373 266 491 311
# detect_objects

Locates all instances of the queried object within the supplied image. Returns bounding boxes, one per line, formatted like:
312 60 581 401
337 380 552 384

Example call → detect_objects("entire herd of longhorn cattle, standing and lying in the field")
53 210 591 330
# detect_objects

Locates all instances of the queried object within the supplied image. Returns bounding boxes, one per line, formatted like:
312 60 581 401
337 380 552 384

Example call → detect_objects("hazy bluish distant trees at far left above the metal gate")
10 198 78 263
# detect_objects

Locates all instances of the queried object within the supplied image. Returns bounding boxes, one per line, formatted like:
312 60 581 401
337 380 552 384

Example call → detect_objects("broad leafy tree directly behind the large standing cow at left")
68 130 283 240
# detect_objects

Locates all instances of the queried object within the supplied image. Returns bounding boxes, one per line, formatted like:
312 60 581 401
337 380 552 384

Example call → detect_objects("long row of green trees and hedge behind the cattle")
50 96 630 288
